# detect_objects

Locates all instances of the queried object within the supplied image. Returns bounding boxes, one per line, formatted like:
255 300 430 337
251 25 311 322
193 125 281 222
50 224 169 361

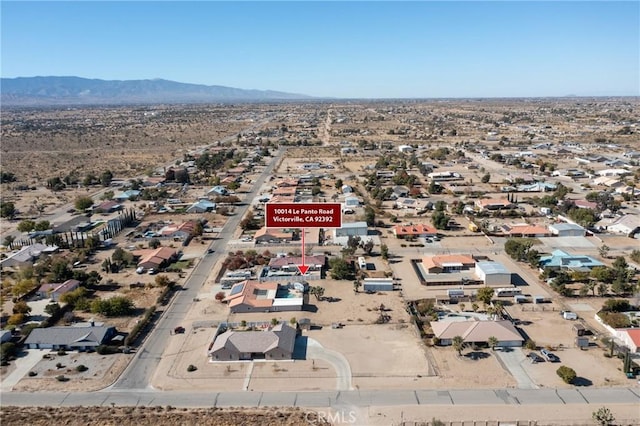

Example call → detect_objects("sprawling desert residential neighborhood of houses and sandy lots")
0 101 640 424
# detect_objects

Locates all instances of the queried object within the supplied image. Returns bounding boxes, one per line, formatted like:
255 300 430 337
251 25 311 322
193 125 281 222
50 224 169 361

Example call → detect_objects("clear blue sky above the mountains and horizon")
1 0 640 98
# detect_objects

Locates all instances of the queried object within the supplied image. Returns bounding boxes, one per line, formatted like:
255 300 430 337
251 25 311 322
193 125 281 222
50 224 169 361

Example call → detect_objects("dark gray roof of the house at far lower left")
24 326 113 347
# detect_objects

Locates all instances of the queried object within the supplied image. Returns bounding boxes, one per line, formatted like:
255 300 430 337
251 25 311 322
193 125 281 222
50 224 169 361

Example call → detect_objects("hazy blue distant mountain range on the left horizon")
0 77 311 106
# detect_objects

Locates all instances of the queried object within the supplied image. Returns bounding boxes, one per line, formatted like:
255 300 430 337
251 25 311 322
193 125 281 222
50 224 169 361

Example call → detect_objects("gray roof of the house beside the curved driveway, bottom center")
211 324 296 353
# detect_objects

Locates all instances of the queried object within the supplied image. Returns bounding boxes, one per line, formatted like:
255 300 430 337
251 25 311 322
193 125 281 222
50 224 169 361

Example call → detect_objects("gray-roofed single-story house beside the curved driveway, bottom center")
209 324 296 361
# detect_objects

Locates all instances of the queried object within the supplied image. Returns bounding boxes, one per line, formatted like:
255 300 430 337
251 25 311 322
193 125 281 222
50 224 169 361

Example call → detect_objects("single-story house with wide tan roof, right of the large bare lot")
431 320 524 347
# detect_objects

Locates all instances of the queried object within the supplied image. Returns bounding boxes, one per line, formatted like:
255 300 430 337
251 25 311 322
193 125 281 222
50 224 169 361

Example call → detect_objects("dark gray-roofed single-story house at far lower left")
24 322 116 351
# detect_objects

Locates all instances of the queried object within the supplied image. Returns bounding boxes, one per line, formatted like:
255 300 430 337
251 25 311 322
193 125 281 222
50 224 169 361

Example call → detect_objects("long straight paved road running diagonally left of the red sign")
109 149 285 390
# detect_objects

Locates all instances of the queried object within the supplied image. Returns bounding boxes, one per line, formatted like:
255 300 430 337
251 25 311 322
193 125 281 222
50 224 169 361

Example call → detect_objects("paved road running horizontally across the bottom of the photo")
2 388 640 407
